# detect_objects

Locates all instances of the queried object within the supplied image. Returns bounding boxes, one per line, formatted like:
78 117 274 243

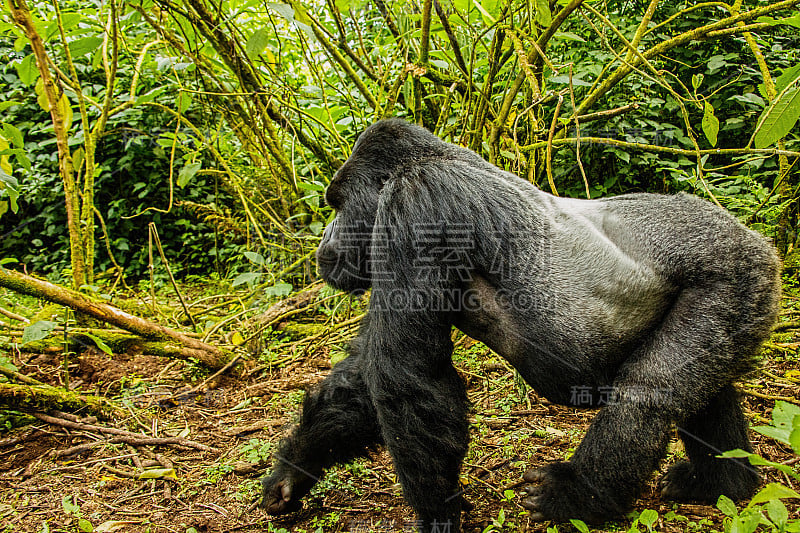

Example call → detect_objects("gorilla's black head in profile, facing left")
317 119 449 293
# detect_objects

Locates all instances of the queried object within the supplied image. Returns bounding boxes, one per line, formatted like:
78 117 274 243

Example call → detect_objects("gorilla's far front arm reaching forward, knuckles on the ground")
261 349 382 515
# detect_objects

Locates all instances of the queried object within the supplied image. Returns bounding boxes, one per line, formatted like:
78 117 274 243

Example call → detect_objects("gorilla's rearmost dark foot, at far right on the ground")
659 459 761 503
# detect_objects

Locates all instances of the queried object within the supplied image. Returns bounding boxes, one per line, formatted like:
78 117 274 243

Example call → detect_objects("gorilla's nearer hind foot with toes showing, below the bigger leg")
522 462 627 524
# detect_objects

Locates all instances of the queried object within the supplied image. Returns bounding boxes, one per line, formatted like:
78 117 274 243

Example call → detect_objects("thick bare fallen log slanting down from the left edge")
0 268 230 369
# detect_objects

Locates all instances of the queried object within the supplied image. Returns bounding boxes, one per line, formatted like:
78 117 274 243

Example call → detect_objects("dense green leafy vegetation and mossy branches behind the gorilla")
0 0 800 531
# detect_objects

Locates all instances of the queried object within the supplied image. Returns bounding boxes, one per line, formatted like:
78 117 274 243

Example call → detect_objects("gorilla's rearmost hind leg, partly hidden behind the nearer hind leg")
661 385 761 503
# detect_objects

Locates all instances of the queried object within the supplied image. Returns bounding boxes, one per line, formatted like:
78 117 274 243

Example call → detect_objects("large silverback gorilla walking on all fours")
261 119 780 532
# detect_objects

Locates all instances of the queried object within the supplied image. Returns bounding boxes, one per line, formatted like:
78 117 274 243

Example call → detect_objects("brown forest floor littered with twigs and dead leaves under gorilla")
0 296 800 533
